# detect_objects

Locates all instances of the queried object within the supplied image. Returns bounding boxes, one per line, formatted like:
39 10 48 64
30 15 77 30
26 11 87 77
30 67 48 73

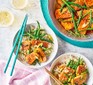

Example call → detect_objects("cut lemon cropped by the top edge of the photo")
11 0 28 9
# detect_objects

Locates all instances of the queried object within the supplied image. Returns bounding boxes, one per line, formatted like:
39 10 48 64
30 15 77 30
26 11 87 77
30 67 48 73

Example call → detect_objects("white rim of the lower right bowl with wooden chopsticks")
50 52 93 84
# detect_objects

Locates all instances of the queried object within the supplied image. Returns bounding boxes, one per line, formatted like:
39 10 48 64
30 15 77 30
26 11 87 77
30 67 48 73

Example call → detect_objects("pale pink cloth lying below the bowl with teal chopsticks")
0 61 51 85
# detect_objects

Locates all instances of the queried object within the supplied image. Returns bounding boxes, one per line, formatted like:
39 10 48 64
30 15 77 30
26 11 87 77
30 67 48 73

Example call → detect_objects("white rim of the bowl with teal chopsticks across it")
12 23 58 69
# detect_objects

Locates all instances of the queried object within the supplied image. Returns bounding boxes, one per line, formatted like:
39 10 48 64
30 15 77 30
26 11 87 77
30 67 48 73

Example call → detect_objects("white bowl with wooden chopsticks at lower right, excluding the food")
50 52 93 85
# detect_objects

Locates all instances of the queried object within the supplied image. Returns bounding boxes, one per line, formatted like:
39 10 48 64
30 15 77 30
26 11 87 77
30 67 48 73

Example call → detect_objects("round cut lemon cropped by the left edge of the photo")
0 9 14 27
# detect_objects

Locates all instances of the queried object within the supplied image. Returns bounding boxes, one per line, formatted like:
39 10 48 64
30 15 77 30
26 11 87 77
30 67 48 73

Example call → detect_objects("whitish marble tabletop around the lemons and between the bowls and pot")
0 0 93 64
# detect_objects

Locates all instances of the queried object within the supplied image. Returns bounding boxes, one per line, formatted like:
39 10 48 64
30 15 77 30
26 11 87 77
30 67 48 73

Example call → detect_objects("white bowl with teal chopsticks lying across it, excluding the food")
13 23 58 69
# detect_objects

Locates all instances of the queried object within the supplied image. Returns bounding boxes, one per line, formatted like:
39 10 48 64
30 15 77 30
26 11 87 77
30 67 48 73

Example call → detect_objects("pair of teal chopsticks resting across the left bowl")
4 15 28 76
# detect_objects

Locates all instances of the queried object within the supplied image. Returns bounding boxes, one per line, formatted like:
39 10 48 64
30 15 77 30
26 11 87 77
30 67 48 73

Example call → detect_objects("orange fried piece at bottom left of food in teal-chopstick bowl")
26 52 39 64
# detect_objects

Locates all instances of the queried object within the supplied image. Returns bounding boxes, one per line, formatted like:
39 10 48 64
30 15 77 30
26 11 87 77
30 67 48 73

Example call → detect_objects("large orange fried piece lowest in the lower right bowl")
71 74 88 85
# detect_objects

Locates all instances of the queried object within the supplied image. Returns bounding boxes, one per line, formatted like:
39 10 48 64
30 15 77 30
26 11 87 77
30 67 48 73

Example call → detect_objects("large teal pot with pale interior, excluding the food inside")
40 0 93 48
